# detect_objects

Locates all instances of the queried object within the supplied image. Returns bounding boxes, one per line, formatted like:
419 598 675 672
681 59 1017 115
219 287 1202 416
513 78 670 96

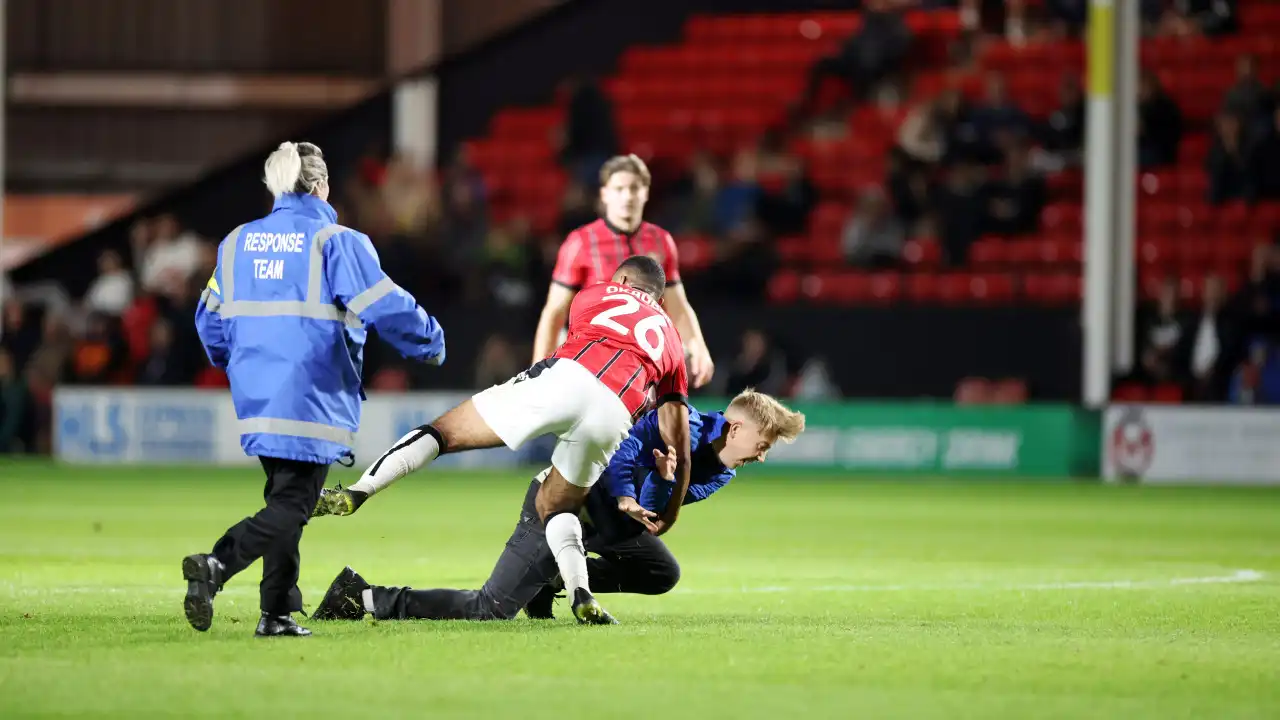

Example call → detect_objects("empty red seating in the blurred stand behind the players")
460 3 1280 304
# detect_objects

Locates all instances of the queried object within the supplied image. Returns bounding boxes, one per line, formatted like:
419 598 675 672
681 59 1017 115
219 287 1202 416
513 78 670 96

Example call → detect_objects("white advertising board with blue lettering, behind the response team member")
54 387 550 468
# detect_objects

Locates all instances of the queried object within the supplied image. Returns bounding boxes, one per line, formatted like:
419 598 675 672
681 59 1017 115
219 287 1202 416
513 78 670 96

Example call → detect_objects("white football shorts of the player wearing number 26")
471 357 631 488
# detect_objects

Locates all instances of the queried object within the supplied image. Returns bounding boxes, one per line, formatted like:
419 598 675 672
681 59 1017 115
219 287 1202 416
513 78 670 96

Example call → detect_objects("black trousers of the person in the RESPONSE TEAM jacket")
214 457 329 615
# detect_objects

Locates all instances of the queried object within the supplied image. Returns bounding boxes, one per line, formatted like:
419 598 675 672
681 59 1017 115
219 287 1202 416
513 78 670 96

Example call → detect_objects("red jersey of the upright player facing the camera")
552 219 680 290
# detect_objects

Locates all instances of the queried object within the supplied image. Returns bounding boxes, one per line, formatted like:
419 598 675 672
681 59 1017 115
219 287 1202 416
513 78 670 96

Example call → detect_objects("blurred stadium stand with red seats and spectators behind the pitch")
0 0 1280 445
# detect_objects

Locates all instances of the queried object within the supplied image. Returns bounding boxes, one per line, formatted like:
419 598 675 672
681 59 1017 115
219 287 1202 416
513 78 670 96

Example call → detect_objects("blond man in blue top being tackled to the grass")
312 389 804 620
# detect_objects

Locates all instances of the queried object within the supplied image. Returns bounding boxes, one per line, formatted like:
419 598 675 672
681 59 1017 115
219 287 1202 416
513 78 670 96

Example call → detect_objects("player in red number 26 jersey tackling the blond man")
314 255 690 624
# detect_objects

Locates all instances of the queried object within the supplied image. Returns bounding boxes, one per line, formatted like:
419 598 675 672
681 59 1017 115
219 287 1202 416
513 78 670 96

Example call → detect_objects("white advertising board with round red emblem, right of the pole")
1102 405 1280 484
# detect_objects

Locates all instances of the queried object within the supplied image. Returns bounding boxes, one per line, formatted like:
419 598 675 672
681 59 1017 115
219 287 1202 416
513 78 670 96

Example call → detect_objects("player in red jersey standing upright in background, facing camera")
532 155 716 388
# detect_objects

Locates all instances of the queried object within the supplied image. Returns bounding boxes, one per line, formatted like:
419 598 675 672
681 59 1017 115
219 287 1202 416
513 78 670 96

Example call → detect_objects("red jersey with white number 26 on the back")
552 283 689 418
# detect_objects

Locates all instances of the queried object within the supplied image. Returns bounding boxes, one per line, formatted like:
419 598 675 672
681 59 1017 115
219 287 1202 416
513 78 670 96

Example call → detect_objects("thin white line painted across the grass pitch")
0 570 1266 600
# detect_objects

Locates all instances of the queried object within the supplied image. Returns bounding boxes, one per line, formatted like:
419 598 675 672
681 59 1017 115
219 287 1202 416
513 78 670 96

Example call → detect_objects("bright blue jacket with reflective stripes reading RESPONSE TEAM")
196 192 444 464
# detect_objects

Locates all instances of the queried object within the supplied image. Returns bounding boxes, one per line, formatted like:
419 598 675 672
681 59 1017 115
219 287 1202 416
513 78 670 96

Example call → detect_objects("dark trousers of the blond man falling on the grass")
371 480 680 620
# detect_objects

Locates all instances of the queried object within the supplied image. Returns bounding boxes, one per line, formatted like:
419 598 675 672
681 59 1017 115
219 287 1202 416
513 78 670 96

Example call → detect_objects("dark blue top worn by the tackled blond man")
596 407 736 512
